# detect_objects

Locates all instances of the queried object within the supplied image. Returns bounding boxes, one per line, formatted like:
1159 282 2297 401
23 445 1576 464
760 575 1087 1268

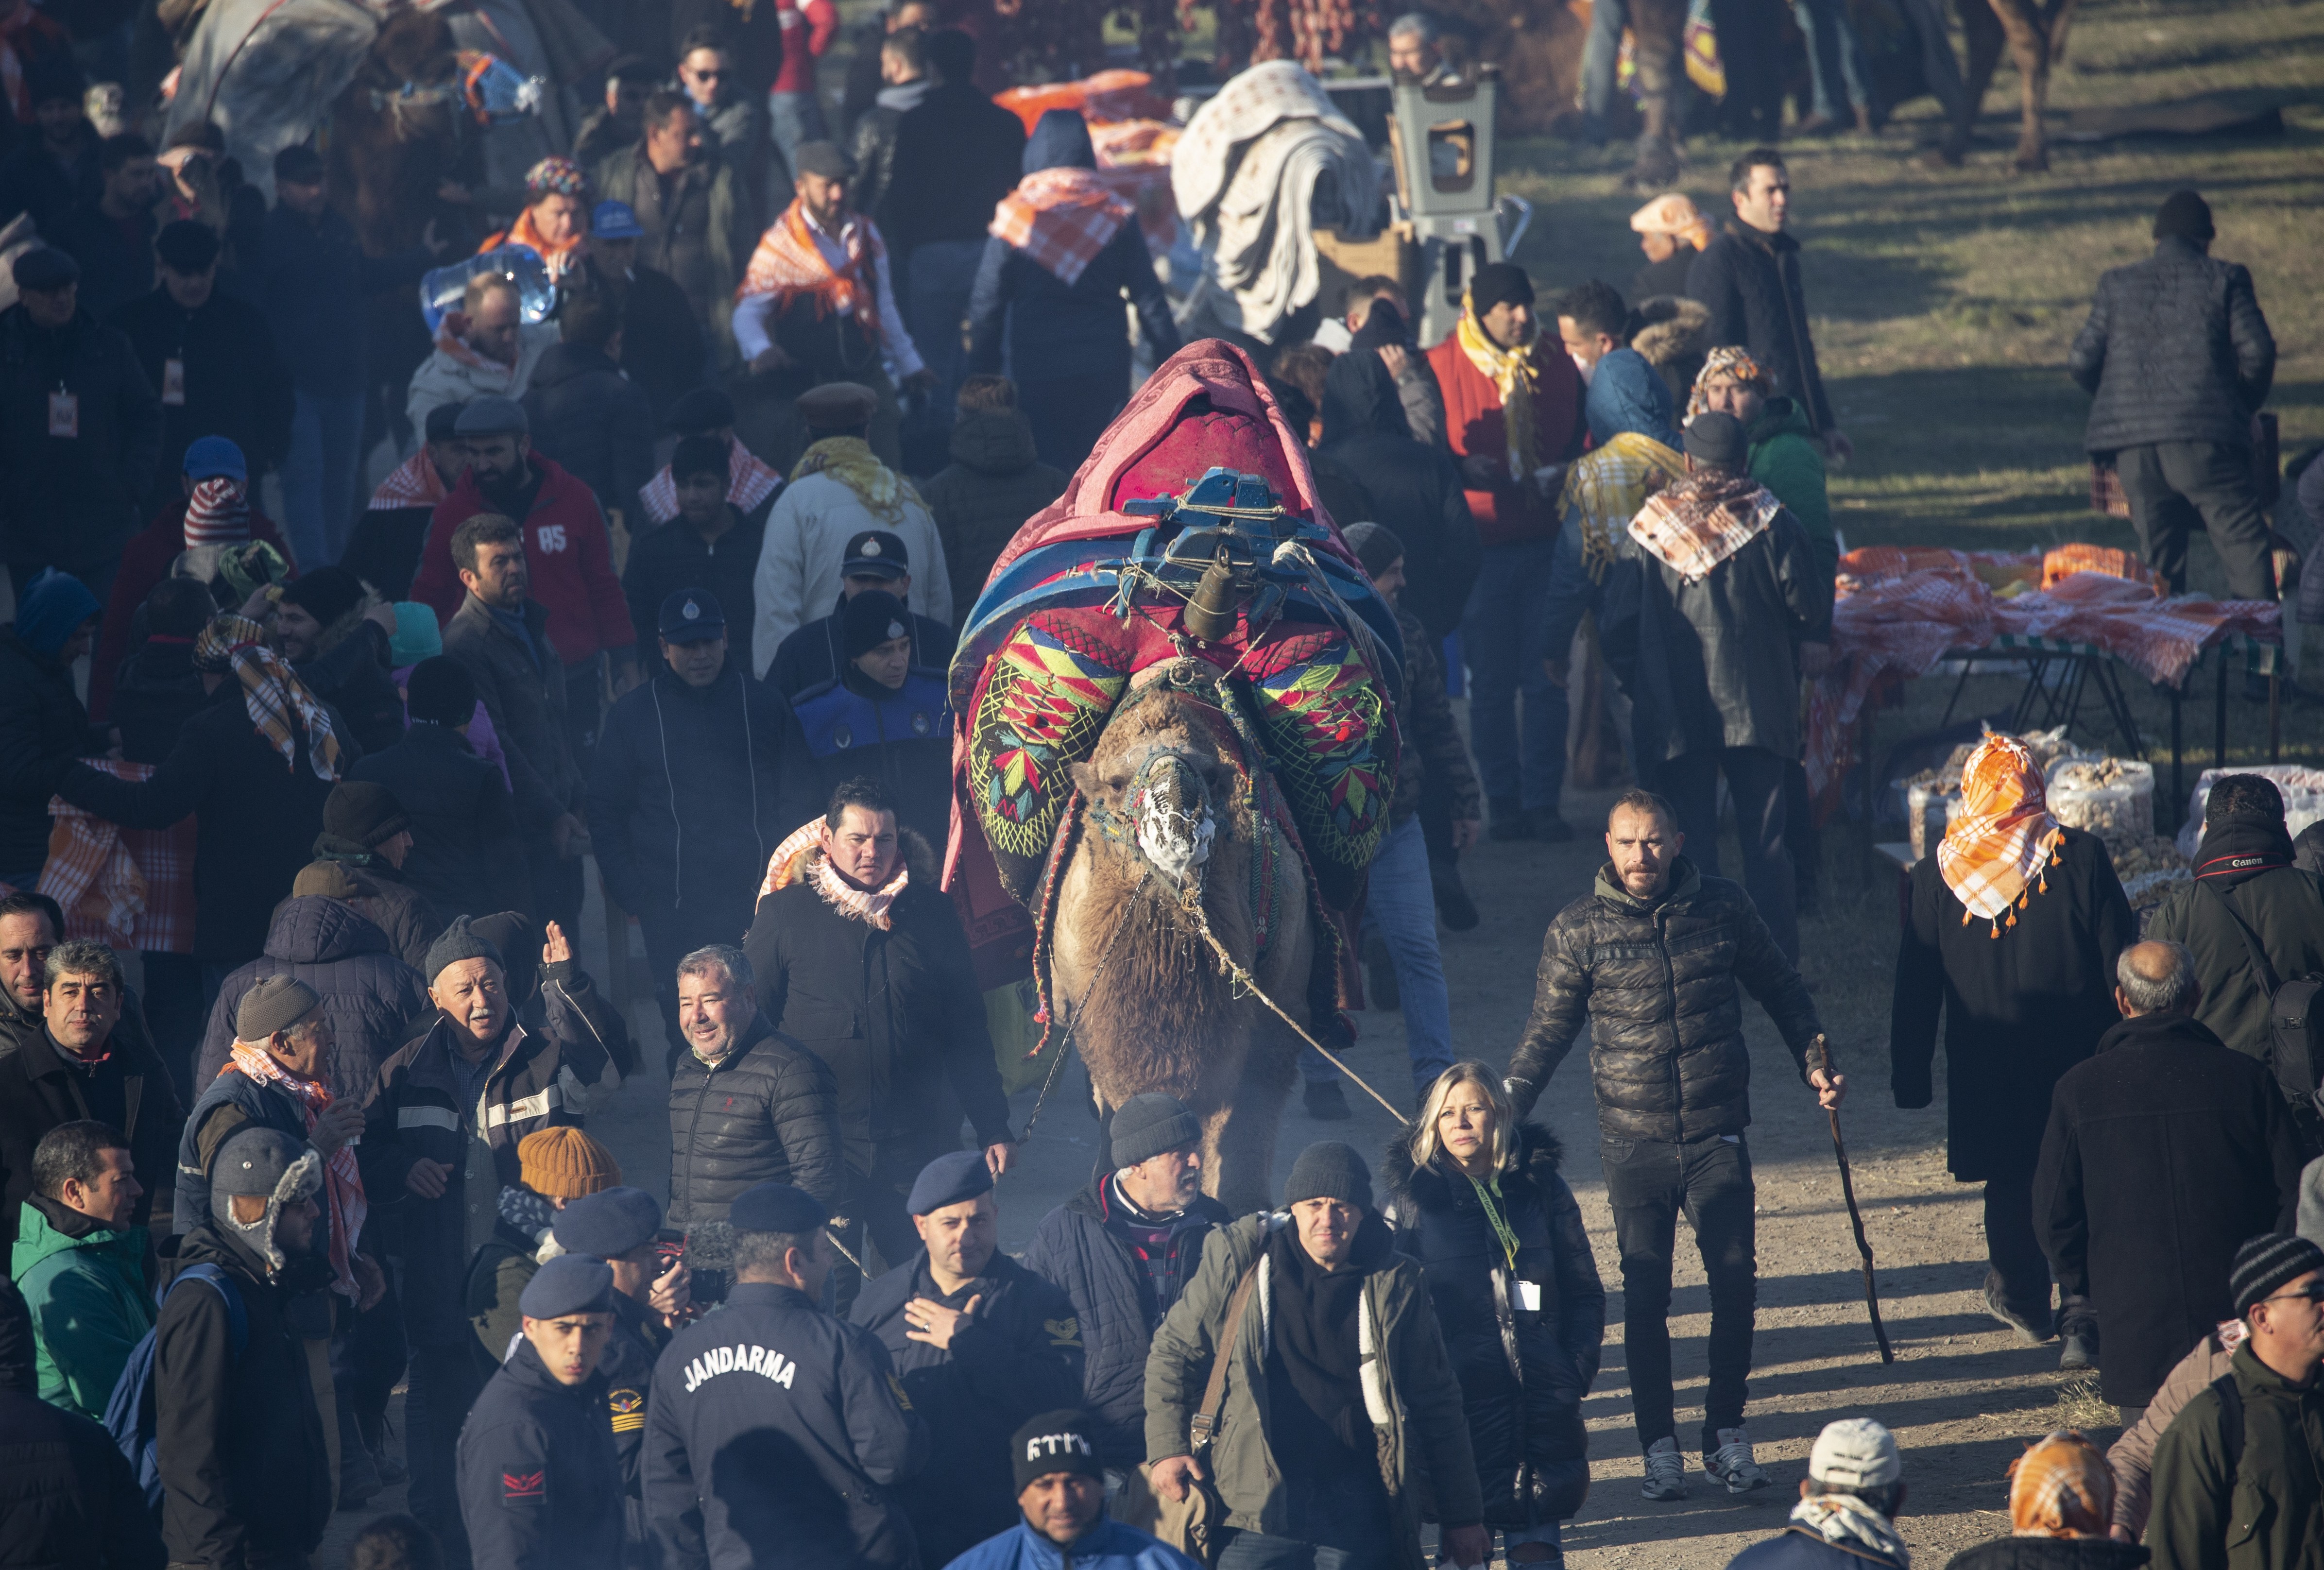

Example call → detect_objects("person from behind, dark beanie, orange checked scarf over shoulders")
969 109 1178 474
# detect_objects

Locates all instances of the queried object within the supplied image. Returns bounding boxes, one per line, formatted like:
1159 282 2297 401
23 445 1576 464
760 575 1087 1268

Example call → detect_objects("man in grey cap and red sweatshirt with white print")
411 397 639 778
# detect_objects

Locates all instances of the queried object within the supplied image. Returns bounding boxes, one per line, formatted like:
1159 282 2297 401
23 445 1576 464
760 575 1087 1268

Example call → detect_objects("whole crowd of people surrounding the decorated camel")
0 0 2324 1570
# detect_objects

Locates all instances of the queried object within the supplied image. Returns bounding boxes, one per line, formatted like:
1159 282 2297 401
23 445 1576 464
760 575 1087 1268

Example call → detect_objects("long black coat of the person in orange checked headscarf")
1889 829 2138 1182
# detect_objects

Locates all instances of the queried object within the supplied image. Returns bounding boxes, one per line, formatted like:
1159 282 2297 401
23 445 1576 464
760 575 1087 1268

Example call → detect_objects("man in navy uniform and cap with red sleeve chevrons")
460 1254 620 1570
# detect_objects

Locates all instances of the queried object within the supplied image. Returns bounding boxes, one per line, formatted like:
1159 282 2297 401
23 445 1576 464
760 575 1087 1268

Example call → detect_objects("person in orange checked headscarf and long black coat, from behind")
1889 736 2138 1368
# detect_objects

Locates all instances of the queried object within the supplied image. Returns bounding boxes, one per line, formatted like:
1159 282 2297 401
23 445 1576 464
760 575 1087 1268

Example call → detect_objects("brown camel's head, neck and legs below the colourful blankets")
1050 660 1325 1214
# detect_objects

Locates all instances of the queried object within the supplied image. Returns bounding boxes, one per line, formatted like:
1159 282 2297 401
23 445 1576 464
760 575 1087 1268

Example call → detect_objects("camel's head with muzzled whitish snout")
1074 692 1234 887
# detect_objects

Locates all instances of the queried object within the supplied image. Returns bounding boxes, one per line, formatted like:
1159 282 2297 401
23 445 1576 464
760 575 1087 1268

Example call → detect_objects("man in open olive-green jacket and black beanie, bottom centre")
1146 1141 1492 1570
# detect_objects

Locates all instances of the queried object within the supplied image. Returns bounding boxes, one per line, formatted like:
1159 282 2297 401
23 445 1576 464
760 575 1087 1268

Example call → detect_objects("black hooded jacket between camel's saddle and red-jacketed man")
1316 353 1483 650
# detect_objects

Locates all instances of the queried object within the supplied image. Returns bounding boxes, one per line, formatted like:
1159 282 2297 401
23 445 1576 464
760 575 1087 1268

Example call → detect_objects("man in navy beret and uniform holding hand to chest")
853 1150 1081 1565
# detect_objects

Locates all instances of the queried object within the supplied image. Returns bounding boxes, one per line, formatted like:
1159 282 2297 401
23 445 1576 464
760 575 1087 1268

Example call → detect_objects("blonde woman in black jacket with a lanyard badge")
1383 1061 1606 1565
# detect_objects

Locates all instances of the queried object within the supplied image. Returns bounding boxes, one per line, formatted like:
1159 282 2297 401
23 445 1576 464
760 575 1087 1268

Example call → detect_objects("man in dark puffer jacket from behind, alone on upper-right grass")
2066 190 2275 599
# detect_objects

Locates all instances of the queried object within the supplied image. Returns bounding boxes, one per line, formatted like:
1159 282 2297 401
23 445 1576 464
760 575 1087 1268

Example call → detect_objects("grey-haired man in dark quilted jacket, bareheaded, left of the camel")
669 943 846 1231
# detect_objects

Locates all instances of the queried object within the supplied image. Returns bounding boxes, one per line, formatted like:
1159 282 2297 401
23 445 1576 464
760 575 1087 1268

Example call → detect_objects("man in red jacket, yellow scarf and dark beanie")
1429 262 1587 841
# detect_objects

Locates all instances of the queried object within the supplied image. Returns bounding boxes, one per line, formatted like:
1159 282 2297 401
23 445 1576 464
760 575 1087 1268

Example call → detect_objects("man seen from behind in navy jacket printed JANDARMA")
644 1182 943 1570
